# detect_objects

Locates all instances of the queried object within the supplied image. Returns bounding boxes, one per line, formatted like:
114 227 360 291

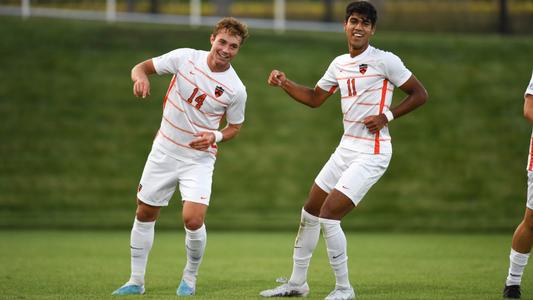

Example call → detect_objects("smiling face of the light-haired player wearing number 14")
207 30 242 72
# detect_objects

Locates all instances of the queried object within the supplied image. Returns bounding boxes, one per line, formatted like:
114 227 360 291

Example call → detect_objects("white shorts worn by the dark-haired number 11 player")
315 147 392 206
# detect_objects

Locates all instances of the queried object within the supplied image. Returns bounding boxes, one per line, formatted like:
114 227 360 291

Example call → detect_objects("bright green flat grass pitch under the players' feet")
0 229 533 300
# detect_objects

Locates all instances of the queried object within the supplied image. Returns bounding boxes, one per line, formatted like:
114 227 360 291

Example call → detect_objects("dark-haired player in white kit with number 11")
260 1 428 299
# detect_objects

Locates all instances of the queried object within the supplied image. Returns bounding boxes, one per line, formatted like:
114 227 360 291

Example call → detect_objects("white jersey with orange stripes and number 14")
152 48 246 161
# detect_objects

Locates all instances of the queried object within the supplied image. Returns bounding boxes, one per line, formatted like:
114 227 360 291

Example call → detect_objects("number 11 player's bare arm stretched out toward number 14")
268 70 331 108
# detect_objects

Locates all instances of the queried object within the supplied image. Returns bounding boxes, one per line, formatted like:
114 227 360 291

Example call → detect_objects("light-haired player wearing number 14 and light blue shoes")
113 18 248 296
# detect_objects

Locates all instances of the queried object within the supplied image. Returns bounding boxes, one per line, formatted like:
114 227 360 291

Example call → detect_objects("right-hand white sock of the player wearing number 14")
183 224 207 287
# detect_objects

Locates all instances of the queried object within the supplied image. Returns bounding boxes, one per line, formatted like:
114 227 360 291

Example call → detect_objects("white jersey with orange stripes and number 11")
317 46 412 154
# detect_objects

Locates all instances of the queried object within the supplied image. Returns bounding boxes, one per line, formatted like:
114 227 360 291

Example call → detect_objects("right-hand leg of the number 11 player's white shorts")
335 153 391 206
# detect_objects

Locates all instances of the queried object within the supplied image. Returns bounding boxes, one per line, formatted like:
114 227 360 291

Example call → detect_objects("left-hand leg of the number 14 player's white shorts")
137 149 179 206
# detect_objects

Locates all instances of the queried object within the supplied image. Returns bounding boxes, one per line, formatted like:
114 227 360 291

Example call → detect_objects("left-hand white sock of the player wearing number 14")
126 218 155 285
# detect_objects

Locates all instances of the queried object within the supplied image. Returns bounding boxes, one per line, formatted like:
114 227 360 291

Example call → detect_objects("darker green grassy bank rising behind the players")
0 17 533 232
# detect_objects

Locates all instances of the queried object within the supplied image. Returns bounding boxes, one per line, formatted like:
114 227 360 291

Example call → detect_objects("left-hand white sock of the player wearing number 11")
289 209 320 285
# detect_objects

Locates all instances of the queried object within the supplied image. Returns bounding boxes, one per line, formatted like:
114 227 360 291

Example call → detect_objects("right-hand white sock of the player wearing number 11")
319 218 351 288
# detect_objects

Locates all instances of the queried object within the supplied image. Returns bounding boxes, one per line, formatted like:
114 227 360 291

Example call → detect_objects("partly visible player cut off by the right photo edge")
503 74 533 299
